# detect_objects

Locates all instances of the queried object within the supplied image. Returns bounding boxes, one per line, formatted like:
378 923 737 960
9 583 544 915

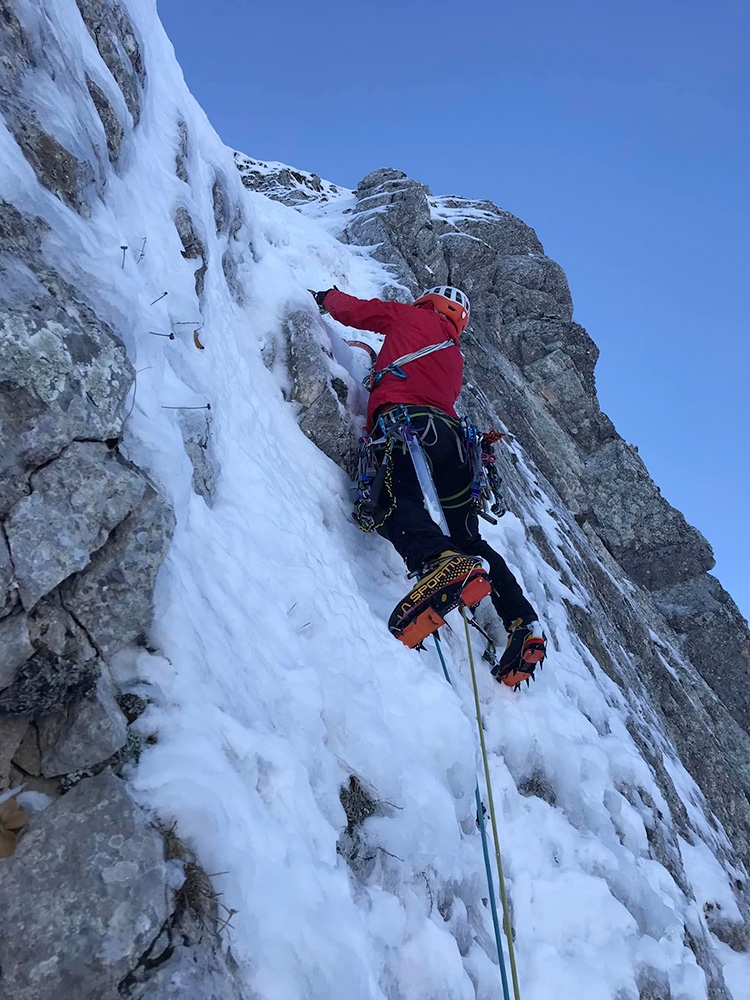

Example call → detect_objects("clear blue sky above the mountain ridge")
158 0 750 616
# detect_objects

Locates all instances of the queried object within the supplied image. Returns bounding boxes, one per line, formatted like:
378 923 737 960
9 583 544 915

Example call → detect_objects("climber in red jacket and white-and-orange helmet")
312 286 545 686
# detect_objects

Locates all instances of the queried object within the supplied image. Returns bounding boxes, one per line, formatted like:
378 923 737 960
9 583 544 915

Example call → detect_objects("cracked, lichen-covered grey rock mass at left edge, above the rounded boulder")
0 197 174 718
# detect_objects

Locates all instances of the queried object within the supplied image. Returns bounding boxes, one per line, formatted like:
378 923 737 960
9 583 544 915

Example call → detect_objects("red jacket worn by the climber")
324 289 464 429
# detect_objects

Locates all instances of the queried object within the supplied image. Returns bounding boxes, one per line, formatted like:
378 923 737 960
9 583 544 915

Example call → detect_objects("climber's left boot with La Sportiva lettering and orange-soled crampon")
388 549 492 649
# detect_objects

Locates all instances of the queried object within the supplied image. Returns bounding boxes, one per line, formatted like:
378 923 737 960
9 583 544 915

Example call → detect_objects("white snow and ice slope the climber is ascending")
0 0 750 1000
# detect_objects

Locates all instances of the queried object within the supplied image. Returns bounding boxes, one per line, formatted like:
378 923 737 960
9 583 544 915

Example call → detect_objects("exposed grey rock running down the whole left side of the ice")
0 0 242 1000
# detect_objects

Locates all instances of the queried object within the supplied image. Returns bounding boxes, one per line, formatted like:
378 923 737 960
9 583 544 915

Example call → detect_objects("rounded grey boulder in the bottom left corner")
0 774 170 1000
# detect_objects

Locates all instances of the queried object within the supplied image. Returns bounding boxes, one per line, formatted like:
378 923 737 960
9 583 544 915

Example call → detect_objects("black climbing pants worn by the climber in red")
378 406 536 629
